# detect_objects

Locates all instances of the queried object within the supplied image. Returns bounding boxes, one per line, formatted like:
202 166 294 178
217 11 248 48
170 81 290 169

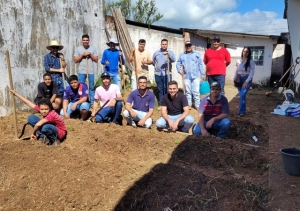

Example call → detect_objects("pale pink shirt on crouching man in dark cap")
94 84 121 107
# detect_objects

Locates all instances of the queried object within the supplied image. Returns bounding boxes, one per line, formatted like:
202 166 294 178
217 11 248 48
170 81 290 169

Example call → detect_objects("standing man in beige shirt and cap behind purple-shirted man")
128 39 152 91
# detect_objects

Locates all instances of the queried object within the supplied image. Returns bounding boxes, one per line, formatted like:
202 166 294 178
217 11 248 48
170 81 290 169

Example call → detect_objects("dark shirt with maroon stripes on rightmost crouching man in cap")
199 95 229 121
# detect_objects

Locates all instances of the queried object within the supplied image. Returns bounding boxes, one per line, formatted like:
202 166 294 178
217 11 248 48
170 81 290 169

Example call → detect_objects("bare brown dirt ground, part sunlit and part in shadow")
0 84 292 211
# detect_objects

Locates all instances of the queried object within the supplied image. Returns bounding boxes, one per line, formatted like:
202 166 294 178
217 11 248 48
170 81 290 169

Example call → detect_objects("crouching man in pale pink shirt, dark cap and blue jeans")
92 72 123 124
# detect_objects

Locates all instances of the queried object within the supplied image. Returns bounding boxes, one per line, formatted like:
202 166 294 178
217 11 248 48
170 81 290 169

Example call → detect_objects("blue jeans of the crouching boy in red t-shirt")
27 114 58 142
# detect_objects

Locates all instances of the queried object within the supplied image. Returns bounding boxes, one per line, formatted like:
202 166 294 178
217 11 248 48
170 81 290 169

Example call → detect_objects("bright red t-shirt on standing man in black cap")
203 48 230 75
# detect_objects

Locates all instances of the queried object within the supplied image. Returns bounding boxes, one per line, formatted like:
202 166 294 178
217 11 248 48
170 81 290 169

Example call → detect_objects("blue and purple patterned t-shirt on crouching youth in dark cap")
64 83 89 103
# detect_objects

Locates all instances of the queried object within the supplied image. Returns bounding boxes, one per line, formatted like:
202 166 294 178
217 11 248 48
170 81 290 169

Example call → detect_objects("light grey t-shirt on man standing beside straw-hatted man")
74 46 98 74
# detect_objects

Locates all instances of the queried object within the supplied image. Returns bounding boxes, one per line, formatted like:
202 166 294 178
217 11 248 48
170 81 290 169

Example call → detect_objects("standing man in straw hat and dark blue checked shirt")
44 40 67 97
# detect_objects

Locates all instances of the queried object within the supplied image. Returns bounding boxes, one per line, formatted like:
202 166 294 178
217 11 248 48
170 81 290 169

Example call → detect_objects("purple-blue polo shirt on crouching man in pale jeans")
127 89 155 112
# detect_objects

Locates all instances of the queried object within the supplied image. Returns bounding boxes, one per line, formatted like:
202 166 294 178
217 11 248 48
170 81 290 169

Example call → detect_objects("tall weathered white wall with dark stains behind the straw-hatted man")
0 0 104 116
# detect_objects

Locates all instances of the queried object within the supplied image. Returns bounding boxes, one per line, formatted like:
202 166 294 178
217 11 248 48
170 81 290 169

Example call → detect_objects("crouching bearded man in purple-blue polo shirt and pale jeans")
123 76 155 128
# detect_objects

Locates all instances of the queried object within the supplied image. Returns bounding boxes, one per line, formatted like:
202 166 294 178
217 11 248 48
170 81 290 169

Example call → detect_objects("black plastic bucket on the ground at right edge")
280 148 300 176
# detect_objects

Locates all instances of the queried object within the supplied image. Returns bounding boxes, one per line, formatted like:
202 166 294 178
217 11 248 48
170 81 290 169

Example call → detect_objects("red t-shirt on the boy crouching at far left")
34 105 67 140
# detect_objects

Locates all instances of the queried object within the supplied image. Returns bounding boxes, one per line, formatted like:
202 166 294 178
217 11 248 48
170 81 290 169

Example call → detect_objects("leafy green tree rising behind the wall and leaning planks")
104 0 163 24
